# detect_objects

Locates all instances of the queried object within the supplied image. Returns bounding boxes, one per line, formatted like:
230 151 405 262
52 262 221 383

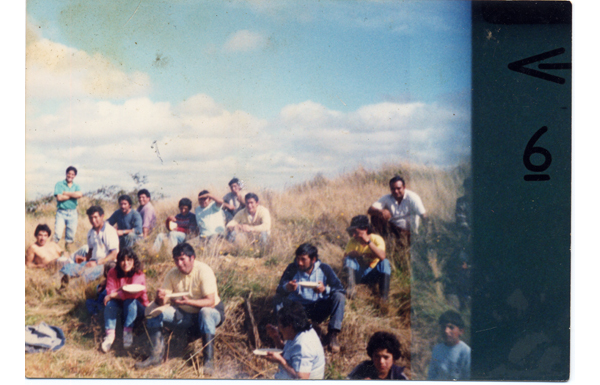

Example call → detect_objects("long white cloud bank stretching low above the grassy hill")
26 94 470 197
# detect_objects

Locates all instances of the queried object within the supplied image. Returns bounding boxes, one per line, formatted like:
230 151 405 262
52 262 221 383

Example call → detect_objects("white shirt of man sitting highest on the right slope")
371 189 425 233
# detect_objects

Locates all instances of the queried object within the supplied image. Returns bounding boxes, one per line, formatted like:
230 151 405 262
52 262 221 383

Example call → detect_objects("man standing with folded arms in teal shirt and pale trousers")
54 166 83 251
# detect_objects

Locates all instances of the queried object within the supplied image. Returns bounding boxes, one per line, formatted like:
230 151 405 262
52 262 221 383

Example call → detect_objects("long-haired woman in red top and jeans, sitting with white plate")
102 247 149 353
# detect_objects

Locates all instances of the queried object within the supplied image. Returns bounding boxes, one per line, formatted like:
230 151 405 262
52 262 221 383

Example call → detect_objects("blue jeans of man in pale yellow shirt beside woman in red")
146 306 221 335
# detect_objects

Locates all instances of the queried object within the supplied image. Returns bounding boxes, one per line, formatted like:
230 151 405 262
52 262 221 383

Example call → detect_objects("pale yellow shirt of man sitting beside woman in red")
162 260 221 314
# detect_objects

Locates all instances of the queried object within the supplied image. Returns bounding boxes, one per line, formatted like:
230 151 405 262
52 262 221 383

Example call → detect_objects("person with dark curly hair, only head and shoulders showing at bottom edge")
348 332 408 380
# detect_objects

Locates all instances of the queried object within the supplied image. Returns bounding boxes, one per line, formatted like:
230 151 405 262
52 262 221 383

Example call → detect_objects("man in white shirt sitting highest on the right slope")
368 175 427 246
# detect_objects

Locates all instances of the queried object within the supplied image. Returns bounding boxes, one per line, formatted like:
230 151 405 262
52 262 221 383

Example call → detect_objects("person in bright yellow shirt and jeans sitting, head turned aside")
344 215 392 301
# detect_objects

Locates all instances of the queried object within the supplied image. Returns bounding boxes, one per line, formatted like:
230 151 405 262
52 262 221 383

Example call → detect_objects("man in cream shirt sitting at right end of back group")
227 193 271 246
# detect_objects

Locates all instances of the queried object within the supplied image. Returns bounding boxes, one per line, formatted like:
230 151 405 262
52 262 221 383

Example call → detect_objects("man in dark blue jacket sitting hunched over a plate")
273 243 346 353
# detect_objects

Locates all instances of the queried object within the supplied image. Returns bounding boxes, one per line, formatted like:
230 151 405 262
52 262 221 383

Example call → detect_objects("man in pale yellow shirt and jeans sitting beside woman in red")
135 242 225 373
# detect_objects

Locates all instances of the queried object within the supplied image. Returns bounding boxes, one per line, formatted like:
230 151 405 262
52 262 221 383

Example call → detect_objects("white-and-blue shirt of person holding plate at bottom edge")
275 328 325 380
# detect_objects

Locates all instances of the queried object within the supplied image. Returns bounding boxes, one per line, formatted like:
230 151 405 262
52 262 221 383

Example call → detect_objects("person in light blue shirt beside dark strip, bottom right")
427 310 471 380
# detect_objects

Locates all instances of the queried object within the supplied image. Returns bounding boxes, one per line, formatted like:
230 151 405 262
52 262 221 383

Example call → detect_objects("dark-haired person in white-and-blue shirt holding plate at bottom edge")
265 301 325 380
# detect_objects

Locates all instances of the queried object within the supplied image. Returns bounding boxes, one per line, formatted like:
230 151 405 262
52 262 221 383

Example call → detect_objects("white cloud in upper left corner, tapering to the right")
25 22 150 99
